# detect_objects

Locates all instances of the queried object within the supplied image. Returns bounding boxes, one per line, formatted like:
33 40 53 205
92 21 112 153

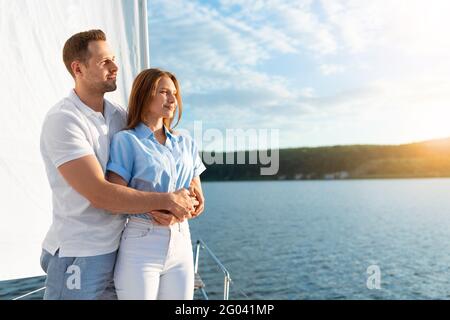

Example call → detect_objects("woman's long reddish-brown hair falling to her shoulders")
125 68 183 132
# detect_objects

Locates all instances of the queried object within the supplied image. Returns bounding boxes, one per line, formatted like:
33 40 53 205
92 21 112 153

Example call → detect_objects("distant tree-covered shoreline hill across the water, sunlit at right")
202 138 450 181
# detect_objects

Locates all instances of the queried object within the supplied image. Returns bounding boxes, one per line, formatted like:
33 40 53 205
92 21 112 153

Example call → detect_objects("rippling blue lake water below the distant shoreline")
0 179 450 299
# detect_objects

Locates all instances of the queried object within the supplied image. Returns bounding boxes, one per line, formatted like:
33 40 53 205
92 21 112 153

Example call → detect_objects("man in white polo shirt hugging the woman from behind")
41 30 199 299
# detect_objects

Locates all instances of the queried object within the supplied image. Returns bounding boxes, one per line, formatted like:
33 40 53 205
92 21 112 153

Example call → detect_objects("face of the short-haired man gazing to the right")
80 41 118 93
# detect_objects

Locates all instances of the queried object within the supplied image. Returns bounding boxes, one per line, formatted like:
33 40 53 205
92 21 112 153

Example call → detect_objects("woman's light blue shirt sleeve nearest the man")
106 131 134 183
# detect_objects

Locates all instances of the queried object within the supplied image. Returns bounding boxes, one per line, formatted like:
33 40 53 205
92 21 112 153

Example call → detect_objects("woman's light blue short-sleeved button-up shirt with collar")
106 122 206 219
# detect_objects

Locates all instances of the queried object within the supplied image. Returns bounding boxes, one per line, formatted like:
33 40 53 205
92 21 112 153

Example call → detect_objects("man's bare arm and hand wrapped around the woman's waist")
58 155 194 218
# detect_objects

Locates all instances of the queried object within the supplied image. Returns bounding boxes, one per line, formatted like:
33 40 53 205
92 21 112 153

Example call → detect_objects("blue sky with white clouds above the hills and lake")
148 0 450 151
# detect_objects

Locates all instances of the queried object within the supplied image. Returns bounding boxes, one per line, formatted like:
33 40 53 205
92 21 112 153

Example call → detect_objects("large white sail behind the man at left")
0 0 148 280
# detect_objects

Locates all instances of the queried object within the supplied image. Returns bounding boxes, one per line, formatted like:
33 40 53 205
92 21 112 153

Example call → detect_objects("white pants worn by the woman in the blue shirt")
114 218 194 300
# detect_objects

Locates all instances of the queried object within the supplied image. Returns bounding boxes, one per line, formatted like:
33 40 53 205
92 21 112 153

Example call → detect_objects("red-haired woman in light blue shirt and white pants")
107 69 205 300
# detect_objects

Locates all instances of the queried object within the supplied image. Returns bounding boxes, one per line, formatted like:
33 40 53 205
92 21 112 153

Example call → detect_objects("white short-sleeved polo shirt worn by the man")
40 90 126 257
